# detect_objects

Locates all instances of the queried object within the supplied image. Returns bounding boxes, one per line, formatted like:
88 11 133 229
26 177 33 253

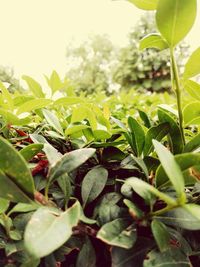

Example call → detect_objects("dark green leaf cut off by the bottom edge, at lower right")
143 248 191 267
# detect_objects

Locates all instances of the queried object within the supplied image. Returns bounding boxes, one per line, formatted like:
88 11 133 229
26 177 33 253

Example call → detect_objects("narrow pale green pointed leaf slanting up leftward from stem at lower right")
153 140 185 201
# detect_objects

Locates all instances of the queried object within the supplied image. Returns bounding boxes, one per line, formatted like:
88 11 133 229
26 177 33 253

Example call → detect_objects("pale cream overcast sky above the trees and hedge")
0 0 200 80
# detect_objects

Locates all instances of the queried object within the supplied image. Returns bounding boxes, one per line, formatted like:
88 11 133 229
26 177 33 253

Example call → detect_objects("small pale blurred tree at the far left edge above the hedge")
0 66 23 93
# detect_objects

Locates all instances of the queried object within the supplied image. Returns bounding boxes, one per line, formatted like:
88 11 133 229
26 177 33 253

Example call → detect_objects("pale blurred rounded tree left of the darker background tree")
66 35 117 94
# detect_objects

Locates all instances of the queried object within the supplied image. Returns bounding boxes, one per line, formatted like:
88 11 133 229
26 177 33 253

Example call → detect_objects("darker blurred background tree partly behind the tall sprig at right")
113 14 188 92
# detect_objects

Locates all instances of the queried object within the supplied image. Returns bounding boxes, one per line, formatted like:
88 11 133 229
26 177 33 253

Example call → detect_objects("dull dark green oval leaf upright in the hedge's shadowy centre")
81 166 108 206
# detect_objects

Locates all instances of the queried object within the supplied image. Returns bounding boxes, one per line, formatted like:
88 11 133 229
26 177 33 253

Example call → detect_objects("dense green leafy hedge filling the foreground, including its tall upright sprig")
0 0 200 267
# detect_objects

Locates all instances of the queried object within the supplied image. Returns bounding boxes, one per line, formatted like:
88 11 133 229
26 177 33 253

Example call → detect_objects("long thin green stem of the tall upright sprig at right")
170 48 185 145
